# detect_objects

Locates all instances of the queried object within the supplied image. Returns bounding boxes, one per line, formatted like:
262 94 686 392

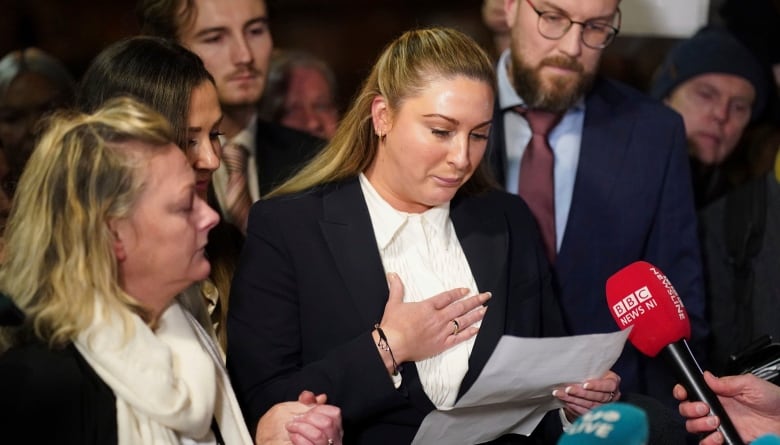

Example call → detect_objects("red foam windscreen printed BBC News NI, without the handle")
607 261 691 357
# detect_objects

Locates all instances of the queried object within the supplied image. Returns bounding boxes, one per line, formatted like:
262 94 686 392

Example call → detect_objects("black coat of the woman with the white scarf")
0 341 117 445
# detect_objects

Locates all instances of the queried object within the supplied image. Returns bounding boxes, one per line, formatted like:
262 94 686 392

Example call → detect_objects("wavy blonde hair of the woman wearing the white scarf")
0 98 175 346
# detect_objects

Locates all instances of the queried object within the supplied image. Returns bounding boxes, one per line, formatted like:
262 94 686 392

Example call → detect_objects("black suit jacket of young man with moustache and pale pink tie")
255 120 325 196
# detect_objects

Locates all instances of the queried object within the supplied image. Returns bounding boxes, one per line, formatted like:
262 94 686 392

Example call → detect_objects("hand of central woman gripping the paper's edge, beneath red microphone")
553 371 620 422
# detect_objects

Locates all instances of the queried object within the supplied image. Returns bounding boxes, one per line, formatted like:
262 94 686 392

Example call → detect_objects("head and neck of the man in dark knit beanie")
651 27 768 208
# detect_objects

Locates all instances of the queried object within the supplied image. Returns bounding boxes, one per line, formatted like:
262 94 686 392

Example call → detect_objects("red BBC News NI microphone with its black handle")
607 261 742 445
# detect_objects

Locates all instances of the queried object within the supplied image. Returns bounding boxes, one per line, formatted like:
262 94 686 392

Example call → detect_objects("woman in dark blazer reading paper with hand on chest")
227 28 619 444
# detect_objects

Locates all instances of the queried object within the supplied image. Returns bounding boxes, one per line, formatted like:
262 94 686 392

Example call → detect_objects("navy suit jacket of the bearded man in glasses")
487 75 708 407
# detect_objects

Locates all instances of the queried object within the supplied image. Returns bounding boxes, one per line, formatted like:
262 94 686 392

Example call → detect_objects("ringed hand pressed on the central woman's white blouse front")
374 273 491 371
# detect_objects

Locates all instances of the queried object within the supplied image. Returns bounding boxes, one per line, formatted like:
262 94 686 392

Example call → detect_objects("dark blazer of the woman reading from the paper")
227 178 563 444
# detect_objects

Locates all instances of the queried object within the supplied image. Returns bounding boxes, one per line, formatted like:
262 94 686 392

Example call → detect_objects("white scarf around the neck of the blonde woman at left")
74 302 252 445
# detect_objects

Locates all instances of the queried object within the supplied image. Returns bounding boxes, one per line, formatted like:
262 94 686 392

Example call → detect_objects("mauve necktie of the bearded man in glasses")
515 107 562 263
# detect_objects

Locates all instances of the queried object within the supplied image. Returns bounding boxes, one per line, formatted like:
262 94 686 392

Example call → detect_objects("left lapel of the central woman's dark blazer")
320 178 388 326
